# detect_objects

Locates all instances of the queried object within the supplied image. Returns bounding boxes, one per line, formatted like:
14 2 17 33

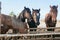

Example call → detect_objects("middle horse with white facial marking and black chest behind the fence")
28 9 40 31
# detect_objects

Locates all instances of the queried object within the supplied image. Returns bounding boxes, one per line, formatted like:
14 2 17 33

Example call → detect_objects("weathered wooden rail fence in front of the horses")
0 27 60 40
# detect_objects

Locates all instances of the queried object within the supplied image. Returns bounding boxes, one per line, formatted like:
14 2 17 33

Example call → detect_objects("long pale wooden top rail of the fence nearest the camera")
0 32 60 37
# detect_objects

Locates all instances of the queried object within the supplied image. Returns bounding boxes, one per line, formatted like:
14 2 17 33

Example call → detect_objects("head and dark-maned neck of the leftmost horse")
17 7 31 22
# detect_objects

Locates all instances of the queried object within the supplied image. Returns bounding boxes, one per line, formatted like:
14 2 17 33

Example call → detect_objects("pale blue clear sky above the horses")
0 0 60 20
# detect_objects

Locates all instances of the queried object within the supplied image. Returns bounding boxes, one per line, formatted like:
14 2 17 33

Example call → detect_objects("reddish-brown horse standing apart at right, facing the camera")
45 5 58 31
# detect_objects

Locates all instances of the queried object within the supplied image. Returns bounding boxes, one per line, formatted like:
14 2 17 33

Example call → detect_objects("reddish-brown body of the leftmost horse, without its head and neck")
0 14 27 34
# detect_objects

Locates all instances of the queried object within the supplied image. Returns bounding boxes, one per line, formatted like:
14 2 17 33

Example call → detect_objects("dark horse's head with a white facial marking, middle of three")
32 9 40 25
